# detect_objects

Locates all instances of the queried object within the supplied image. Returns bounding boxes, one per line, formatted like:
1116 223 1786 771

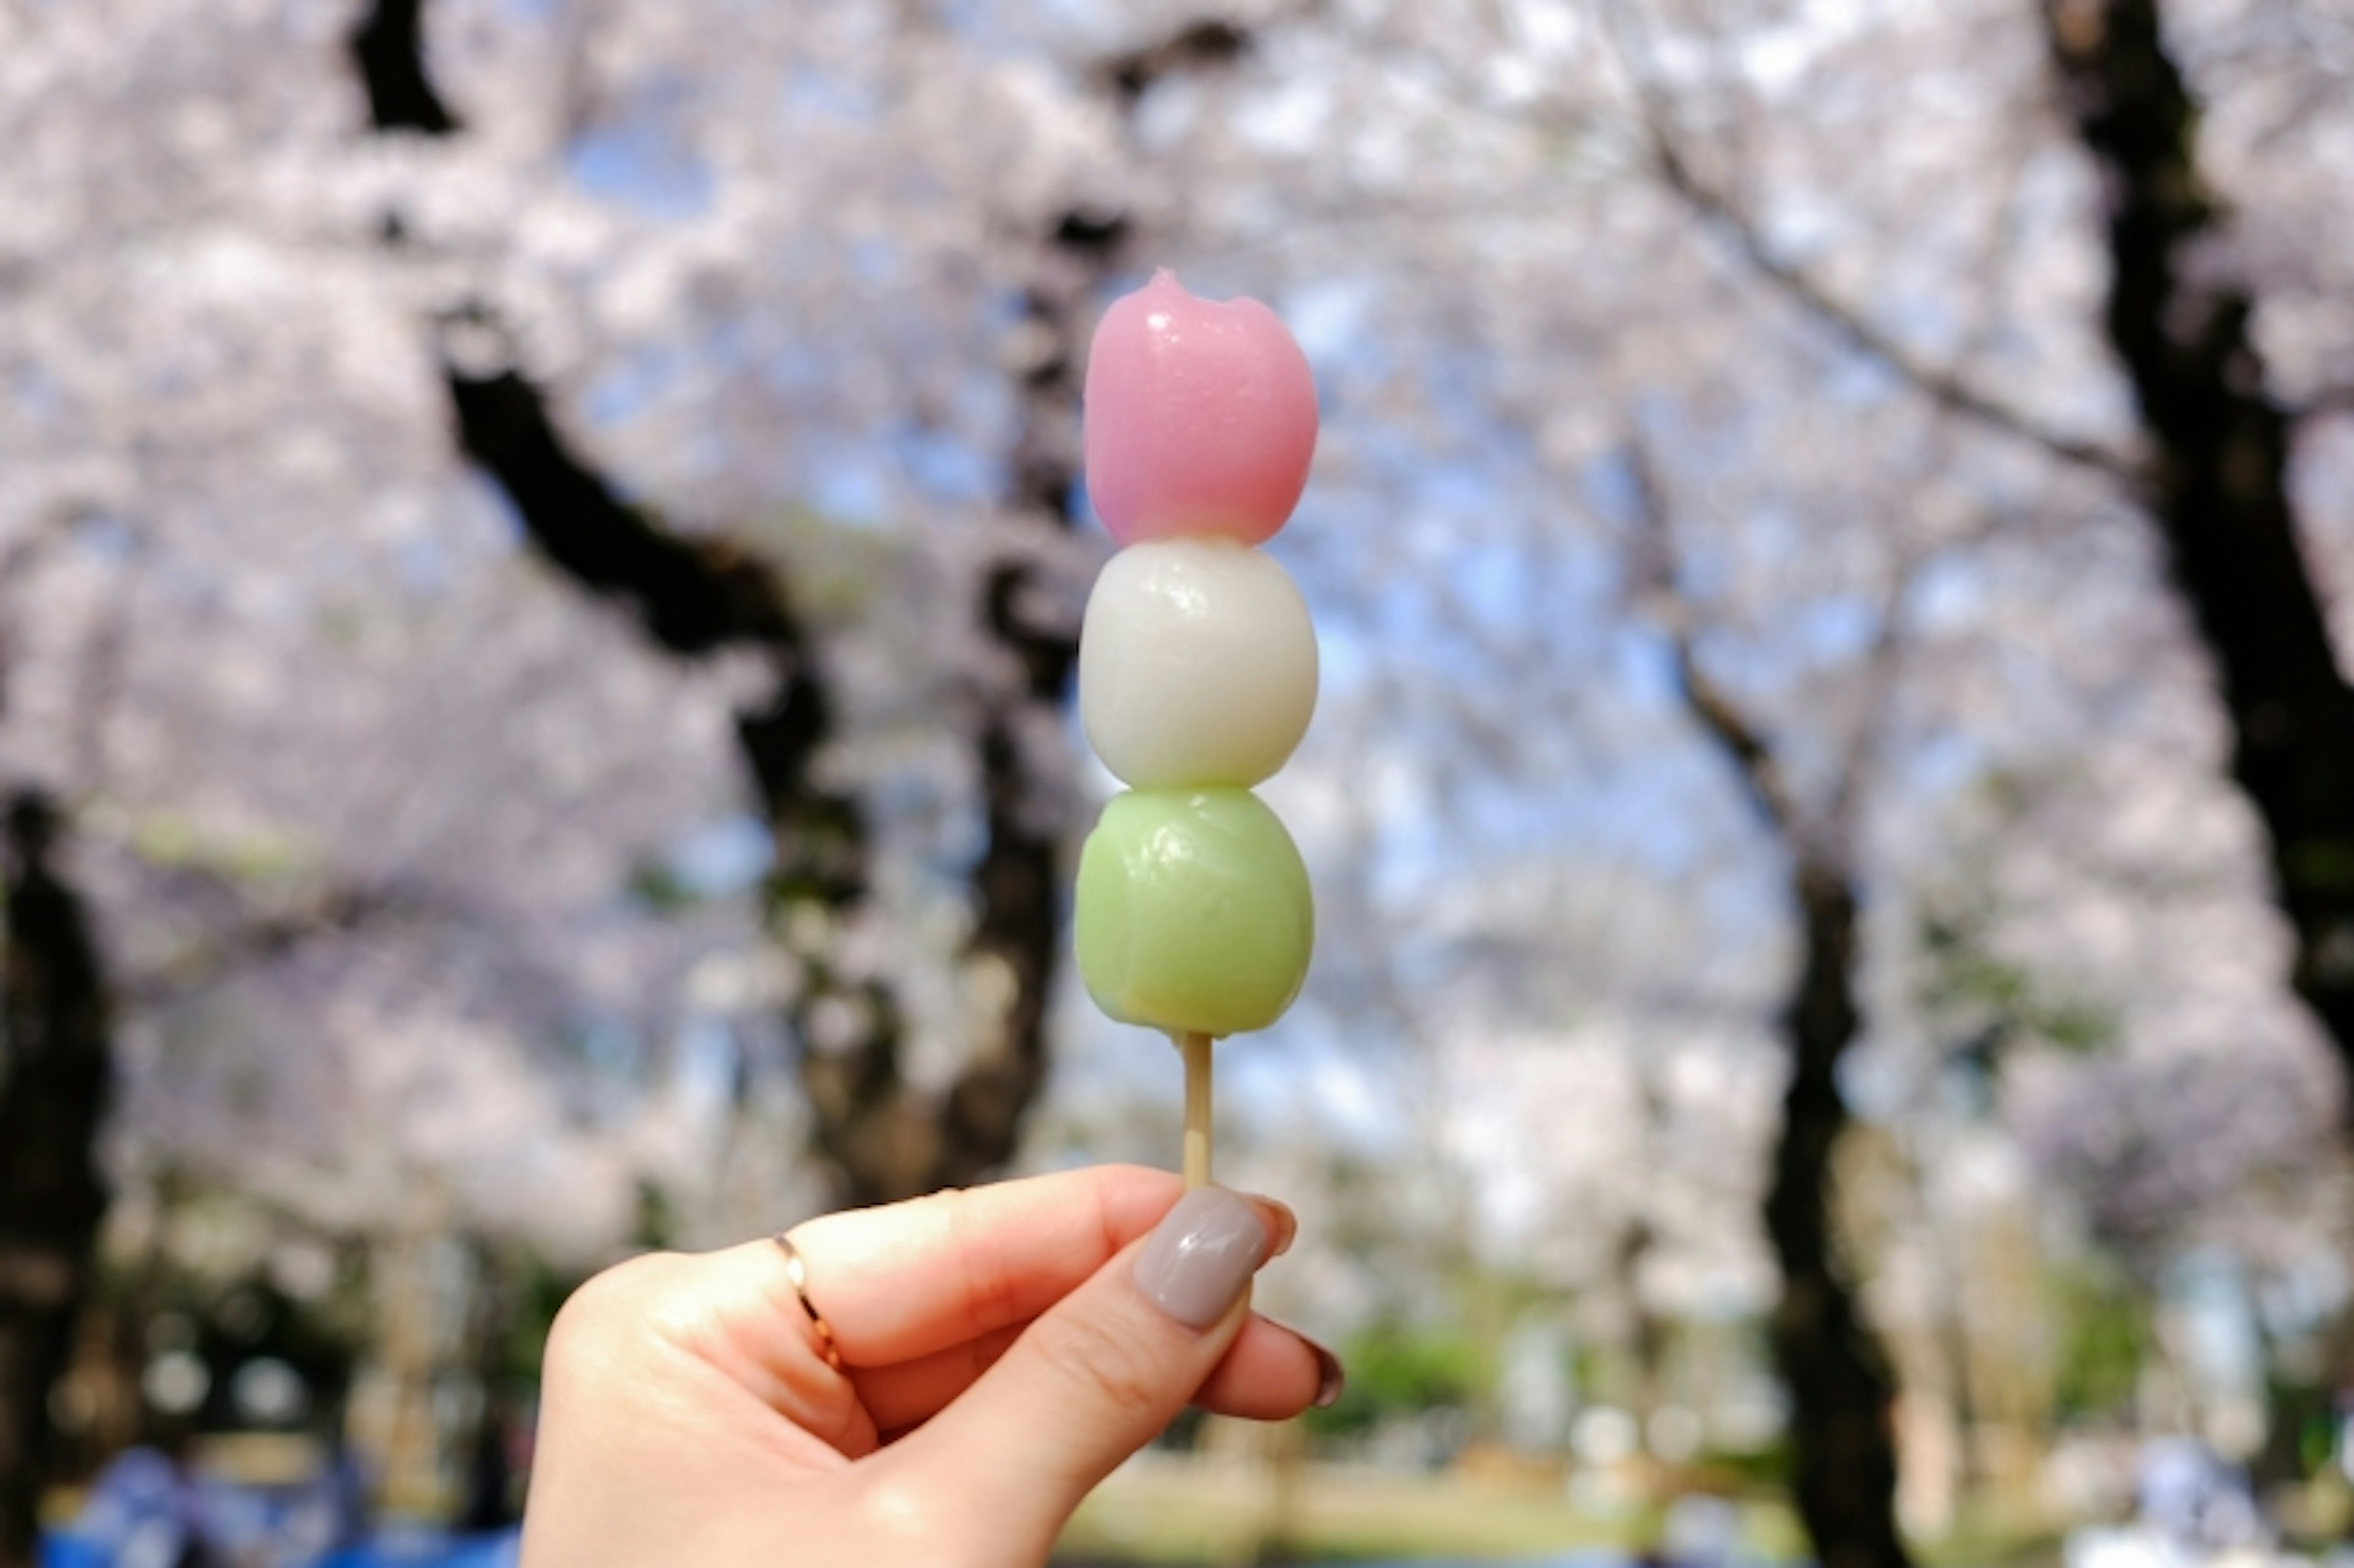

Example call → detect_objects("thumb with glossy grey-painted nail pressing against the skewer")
892 1187 1269 1559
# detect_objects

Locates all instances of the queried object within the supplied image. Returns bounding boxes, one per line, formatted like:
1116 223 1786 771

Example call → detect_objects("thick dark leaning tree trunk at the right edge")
2043 0 2354 1087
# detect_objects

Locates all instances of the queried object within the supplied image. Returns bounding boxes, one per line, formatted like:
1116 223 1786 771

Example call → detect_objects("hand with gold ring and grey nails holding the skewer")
522 1165 1339 1568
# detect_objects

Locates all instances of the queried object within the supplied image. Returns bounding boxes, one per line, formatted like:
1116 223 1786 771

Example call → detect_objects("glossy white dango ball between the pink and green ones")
1078 537 1316 789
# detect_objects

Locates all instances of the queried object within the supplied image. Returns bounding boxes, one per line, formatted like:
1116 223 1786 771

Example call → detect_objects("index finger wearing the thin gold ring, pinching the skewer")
779 1165 1295 1366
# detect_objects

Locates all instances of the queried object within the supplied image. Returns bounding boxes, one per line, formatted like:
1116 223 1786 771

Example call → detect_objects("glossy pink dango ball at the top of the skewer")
1085 268 1316 544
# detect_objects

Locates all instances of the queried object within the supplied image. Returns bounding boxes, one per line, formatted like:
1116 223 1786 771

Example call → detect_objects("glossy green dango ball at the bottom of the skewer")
1076 789 1316 1036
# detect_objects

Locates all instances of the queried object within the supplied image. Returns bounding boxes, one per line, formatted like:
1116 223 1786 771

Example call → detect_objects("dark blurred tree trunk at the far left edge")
0 793 113 1568
